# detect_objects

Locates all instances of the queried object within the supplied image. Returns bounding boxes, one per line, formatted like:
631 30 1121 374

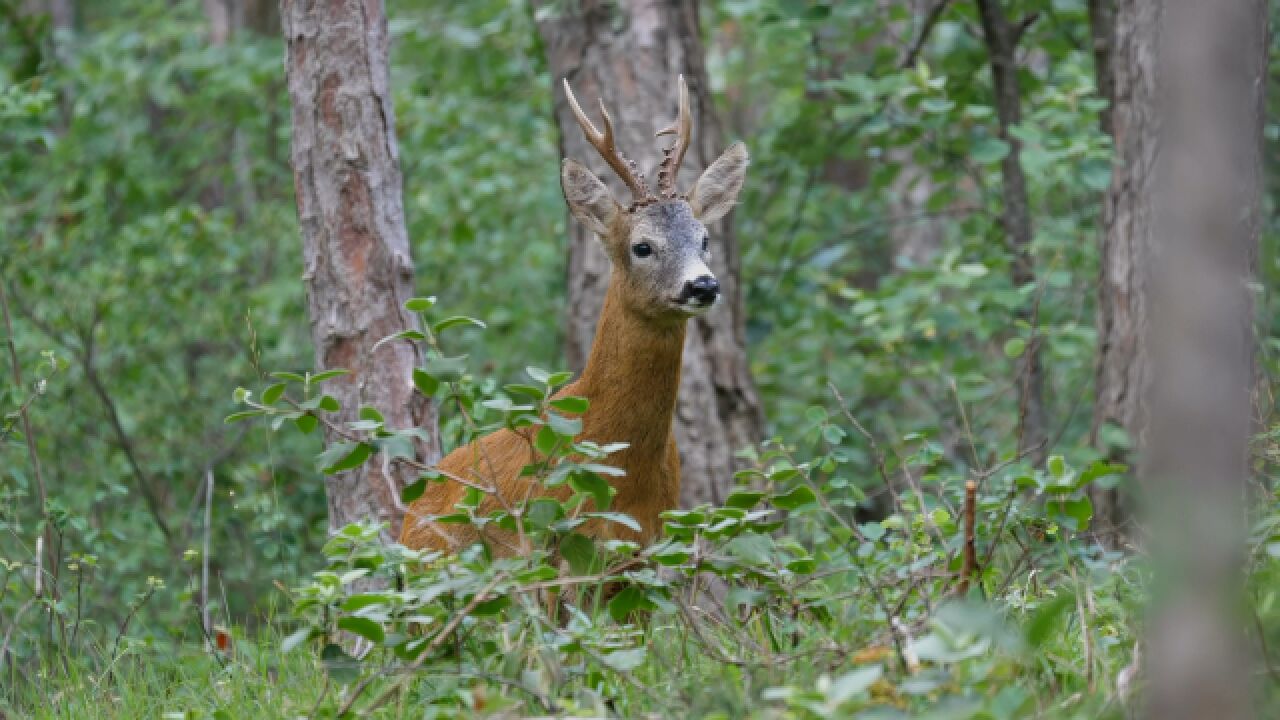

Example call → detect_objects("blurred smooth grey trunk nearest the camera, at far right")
1146 0 1270 720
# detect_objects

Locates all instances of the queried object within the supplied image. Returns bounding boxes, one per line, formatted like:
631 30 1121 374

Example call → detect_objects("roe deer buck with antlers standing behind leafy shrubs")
401 76 748 555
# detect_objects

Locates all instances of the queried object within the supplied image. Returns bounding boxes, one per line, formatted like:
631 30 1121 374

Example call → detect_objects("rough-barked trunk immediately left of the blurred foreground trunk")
1089 0 1160 547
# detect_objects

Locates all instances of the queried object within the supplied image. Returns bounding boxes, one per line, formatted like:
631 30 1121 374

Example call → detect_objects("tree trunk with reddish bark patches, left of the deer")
280 0 440 541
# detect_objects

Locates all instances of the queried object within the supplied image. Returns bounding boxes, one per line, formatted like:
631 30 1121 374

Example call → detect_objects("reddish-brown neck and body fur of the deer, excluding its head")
401 269 686 555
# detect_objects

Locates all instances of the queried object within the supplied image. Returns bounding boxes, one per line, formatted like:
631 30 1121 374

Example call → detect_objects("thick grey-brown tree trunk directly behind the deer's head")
535 0 764 506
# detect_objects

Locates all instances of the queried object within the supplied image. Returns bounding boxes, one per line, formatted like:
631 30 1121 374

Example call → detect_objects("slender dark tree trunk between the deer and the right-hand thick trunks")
978 0 1048 465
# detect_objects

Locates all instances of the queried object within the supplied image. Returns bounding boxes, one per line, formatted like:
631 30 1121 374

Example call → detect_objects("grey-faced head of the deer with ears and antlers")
561 76 748 322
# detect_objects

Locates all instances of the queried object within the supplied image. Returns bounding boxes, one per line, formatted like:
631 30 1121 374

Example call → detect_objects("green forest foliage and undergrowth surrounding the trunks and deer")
0 0 1280 717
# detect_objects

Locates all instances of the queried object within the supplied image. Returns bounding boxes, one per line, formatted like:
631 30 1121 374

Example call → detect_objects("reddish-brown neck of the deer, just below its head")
577 278 687 448
